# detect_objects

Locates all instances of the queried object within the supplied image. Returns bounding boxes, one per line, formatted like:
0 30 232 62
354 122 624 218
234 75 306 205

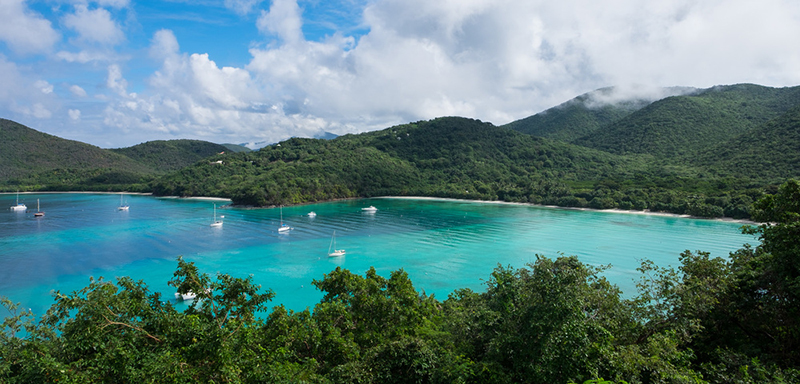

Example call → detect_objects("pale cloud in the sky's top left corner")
0 0 61 53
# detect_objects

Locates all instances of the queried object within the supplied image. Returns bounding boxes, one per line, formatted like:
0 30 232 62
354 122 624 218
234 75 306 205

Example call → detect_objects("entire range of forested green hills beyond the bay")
6 80 800 218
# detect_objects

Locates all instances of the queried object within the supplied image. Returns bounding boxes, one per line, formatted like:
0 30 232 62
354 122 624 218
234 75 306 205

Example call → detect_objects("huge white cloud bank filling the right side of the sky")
247 0 800 129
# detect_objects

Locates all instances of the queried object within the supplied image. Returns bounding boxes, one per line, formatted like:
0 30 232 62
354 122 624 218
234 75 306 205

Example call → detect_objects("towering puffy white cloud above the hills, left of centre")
104 30 295 142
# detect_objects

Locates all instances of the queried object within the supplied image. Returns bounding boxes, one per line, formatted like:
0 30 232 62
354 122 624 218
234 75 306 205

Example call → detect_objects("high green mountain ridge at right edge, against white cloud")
576 84 800 158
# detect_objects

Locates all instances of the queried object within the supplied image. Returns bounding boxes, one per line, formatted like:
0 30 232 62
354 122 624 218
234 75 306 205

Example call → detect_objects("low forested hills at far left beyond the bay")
0 119 228 192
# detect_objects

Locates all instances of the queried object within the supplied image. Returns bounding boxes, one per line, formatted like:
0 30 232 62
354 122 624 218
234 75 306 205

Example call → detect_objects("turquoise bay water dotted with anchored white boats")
0 193 757 316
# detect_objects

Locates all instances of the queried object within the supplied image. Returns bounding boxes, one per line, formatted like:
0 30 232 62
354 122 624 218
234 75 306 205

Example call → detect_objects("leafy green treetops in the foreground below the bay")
0 181 800 383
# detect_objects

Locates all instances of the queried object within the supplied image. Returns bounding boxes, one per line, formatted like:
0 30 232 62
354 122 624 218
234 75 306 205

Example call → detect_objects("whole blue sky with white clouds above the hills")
0 0 800 148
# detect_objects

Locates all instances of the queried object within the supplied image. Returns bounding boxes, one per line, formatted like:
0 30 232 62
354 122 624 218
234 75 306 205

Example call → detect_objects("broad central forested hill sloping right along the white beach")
153 117 763 218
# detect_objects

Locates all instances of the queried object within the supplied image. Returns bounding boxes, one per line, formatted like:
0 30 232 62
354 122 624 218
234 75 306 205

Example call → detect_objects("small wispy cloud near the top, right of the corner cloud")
64 4 125 45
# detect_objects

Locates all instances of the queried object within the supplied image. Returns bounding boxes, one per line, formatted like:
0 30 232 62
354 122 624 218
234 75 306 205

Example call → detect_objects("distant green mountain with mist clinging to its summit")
503 87 676 143
